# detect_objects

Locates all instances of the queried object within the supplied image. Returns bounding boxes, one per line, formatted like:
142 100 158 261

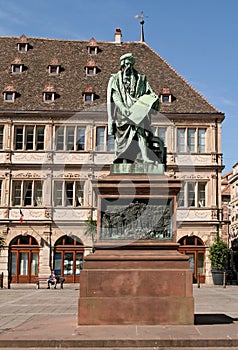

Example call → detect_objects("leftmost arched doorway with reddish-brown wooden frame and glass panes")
9 235 39 283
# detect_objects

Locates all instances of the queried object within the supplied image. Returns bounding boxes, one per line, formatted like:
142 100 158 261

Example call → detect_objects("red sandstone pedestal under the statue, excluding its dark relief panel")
78 175 194 325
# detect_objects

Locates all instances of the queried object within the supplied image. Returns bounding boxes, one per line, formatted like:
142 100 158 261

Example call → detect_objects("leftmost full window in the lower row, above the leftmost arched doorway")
12 180 43 207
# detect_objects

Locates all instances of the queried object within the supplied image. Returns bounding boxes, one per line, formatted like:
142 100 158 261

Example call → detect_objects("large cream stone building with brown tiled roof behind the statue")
0 28 224 285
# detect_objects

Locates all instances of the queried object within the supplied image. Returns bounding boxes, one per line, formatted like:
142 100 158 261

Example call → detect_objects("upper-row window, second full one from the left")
55 126 86 151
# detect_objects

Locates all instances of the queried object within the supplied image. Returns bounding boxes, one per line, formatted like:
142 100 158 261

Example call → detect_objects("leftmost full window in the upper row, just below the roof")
14 125 45 151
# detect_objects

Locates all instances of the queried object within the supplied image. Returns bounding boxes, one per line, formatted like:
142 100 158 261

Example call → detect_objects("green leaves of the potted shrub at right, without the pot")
209 237 228 270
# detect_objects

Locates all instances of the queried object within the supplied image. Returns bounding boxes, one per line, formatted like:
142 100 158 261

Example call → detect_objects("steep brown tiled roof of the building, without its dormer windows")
0 37 222 114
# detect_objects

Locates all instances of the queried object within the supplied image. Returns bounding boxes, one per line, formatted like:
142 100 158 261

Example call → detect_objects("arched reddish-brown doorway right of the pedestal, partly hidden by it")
178 236 205 283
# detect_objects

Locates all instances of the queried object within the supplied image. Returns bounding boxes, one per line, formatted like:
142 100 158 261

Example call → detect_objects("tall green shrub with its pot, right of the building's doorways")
209 236 229 285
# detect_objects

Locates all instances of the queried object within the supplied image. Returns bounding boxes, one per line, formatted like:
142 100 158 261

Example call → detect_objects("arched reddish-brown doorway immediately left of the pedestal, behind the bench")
54 236 84 283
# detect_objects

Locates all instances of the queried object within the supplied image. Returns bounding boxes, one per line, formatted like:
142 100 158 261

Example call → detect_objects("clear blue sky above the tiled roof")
0 0 238 172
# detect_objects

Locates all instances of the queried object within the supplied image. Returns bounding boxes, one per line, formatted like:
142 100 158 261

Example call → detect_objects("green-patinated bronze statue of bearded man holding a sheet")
107 53 164 163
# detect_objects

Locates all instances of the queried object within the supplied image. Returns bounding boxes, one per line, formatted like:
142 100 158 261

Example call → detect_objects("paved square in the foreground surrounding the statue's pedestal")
0 284 238 350
